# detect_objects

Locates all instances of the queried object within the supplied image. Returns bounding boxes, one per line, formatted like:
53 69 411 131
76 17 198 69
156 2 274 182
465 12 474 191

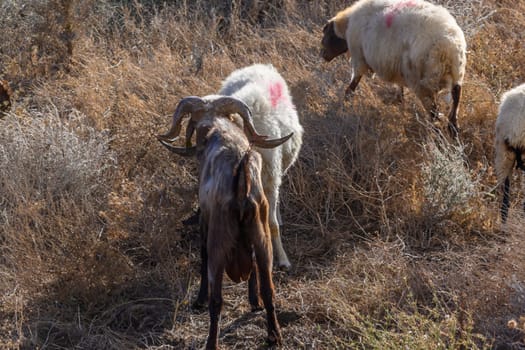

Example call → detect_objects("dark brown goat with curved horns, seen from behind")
158 97 292 349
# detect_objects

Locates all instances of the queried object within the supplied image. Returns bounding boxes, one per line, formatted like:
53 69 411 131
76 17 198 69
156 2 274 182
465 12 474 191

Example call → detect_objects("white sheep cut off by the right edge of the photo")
494 84 525 222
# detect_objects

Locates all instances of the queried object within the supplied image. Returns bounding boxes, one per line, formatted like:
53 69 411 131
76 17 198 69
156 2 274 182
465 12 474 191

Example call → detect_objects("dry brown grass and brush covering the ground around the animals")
0 0 525 349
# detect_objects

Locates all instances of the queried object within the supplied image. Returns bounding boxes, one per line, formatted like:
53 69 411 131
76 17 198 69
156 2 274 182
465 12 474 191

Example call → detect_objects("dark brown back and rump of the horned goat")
199 118 269 282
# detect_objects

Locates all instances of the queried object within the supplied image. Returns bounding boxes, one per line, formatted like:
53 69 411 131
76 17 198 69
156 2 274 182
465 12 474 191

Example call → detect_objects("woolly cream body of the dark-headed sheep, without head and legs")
346 0 466 91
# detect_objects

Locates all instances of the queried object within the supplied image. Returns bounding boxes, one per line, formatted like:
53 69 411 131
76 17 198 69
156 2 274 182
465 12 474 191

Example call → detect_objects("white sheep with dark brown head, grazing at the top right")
321 0 467 135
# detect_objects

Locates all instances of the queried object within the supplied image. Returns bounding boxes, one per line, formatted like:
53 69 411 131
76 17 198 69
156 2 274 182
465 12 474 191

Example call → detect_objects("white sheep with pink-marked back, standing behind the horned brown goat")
159 64 303 269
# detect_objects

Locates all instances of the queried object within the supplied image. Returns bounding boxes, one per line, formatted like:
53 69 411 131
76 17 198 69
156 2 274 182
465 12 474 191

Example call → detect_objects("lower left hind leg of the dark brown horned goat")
206 261 224 350
